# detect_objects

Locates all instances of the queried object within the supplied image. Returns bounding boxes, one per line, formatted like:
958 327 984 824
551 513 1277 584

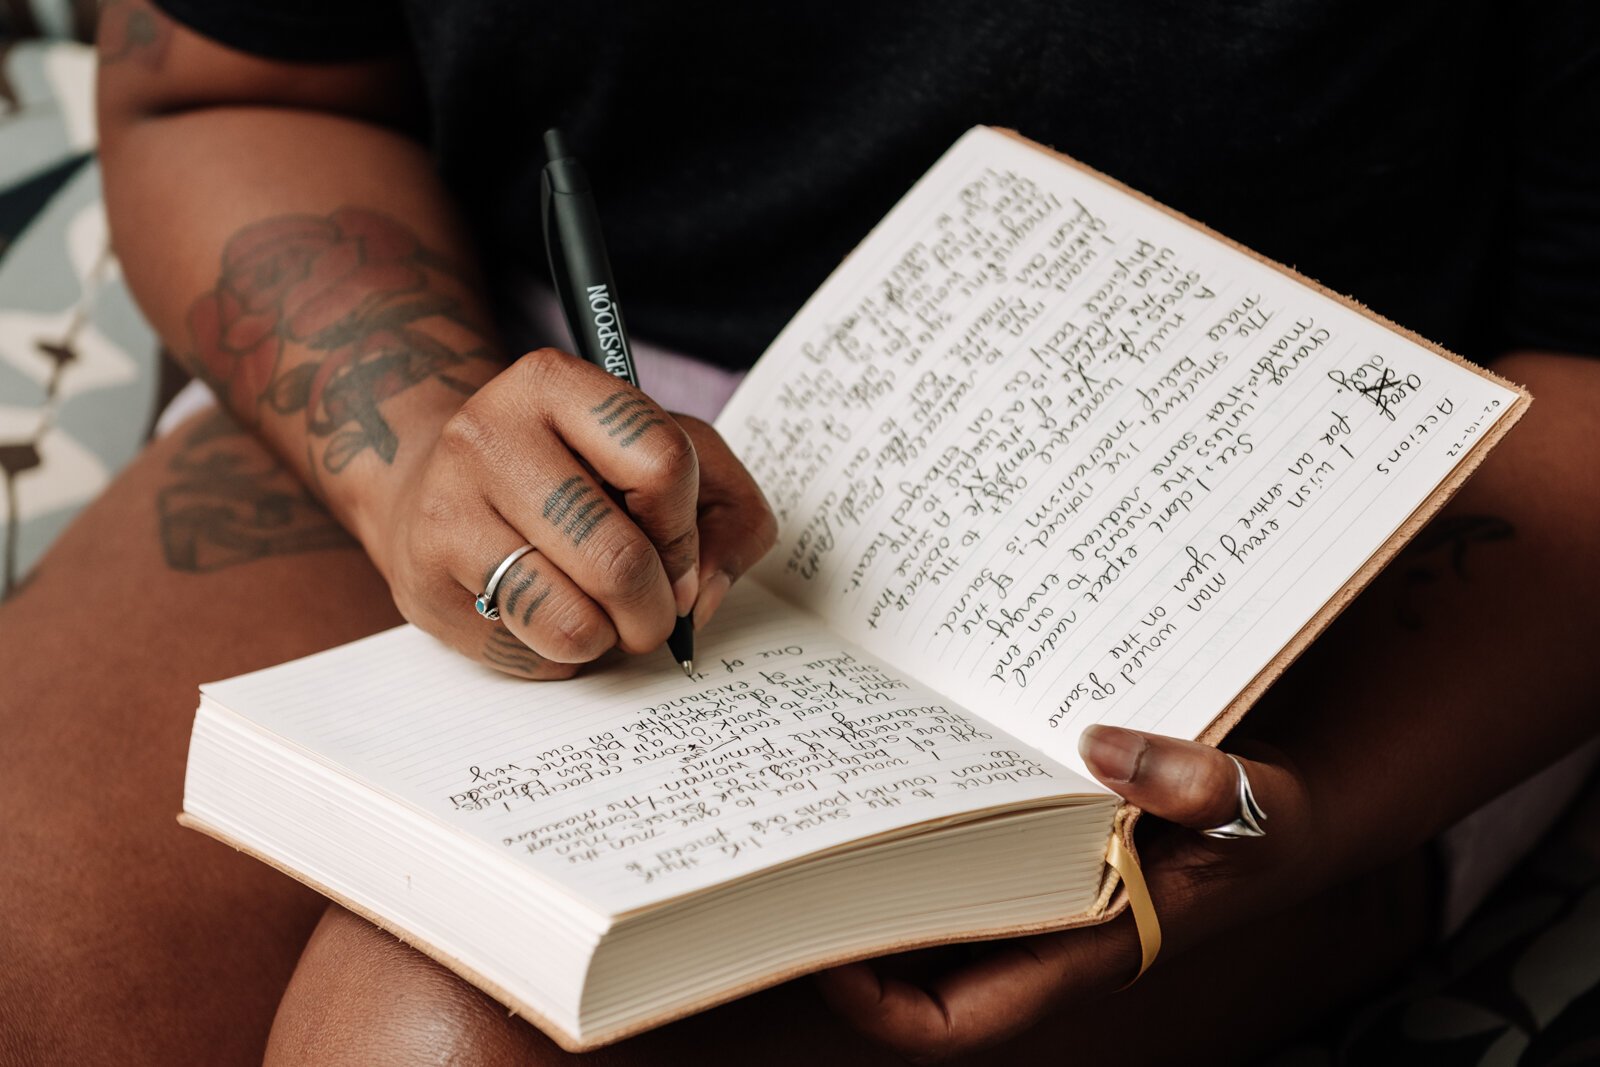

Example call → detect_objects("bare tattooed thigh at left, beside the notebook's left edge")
0 416 398 1064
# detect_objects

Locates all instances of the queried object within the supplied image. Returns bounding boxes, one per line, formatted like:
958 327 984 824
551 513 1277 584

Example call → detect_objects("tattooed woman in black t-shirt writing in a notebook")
0 0 1600 1064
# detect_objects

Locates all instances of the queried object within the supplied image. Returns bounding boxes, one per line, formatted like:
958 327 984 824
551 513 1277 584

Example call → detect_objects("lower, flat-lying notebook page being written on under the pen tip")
202 584 1093 913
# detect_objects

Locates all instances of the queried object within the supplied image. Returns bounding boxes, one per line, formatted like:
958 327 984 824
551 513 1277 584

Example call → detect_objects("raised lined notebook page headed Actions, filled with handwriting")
718 130 1517 780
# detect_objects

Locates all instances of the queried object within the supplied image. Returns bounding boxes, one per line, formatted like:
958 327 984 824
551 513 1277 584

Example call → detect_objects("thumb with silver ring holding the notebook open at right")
1078 726 1283 830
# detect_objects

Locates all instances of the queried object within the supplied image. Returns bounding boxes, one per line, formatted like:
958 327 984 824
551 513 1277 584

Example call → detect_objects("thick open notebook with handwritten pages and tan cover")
184 128 1528 1049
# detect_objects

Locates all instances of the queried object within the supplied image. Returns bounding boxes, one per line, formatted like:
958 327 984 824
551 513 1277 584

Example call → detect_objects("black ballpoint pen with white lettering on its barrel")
539 130 694 677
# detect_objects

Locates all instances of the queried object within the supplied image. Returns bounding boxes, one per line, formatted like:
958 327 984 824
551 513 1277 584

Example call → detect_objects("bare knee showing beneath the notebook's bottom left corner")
266 907 558 1067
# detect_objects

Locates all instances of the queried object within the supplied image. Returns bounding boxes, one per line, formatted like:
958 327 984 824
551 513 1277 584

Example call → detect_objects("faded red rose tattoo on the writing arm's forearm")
189 208 498 474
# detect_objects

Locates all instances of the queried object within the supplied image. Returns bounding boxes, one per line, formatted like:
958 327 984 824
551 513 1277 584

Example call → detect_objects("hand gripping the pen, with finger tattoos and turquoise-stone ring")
368 349 776 678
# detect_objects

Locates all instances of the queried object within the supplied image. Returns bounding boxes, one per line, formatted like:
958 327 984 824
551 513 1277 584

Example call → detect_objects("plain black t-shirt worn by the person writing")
147 0 1600 366
